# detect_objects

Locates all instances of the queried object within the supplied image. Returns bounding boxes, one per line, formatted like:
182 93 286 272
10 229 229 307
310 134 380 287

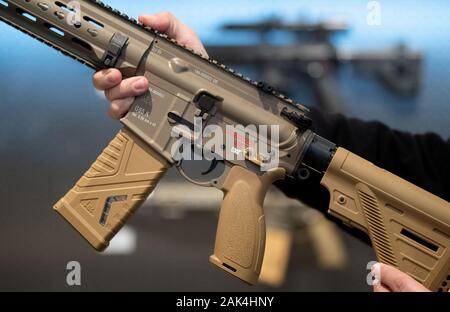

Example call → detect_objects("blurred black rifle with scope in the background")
207 19 423 112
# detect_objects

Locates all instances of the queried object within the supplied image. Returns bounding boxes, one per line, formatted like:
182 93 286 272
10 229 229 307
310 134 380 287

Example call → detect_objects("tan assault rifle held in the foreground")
0 0 450 290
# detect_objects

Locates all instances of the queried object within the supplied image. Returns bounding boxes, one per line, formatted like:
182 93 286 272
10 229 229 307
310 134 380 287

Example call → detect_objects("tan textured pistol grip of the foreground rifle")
210 166 285 284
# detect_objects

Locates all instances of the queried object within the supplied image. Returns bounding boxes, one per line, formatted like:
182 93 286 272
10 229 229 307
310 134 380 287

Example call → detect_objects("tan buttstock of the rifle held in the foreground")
322 148 450 291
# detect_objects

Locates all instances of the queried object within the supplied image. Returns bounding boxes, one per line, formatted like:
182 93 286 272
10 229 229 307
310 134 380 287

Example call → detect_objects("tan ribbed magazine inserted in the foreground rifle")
54 129 169 251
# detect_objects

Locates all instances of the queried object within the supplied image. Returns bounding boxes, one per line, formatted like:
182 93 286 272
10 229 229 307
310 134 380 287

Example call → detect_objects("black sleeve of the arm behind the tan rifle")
278 109 450 212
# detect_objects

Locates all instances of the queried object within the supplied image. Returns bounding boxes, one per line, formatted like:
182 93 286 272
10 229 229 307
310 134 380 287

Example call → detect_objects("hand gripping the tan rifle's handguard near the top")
93 12 208 119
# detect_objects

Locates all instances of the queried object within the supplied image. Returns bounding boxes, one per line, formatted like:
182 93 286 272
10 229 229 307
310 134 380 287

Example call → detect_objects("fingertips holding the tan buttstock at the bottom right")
380 264 429 292
